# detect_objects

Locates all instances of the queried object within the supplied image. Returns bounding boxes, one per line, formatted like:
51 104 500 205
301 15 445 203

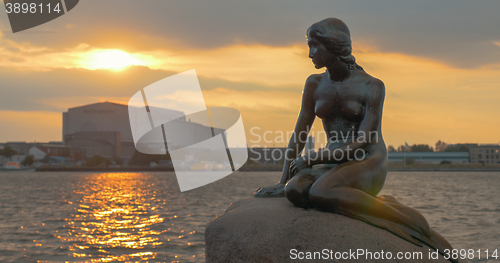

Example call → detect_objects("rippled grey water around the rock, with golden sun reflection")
0 172 500 262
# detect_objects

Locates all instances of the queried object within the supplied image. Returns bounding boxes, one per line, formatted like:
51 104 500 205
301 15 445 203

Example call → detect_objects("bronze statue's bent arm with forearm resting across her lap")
307 79 385 166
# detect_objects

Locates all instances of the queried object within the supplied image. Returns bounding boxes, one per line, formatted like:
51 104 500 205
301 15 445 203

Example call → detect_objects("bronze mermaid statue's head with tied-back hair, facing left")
307 17 359 68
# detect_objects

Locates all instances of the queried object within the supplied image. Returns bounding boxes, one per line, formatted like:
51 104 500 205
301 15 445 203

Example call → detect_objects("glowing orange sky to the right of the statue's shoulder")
358 49 500 145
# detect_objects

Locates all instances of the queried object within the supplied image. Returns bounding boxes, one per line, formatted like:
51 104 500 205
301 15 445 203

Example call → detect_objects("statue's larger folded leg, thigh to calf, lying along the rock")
308 155 431 248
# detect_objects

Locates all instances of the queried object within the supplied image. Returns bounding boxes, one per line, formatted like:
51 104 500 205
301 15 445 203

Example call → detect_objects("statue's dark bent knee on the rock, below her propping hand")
285 168 316 208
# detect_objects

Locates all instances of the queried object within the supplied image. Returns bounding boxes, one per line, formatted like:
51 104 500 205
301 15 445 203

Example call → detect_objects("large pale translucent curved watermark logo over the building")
128 70 248 192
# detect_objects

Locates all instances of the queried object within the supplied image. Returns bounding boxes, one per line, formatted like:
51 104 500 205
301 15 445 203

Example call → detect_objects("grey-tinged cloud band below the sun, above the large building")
0 67 175 112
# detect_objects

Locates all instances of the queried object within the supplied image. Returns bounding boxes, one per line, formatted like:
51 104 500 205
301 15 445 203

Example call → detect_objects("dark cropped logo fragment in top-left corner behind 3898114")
4 0 79 33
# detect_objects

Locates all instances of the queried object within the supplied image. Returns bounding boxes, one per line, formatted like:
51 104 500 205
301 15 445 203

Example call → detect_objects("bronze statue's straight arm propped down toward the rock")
279 75 320 184
